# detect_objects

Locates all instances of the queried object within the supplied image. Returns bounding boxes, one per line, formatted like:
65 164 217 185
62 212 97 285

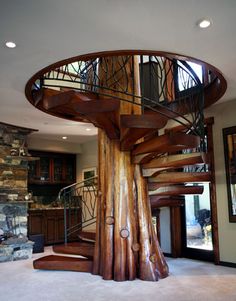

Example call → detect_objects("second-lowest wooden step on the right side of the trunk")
149 185 204 196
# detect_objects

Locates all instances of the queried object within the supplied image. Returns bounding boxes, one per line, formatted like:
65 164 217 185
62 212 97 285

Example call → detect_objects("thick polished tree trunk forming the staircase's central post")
93 57 168 281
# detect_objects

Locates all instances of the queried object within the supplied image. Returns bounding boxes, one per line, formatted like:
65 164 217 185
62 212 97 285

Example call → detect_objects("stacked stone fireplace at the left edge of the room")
0 123 34 262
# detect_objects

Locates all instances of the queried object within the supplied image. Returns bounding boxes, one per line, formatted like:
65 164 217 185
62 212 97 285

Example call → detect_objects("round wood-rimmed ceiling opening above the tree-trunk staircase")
25 50 227 135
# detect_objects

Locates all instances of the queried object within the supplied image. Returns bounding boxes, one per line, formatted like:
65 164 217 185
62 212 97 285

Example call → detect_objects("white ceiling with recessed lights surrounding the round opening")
0 0 236 142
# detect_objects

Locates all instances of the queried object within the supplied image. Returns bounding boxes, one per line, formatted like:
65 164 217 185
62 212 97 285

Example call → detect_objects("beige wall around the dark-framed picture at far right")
205 100 236 263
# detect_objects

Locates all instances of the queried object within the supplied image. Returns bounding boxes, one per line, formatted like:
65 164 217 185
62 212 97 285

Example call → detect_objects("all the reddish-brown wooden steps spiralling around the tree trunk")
31 92 210 272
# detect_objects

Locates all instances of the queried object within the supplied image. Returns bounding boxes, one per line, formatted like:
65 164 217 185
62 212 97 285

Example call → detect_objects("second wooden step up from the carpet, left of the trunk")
53 242 94 259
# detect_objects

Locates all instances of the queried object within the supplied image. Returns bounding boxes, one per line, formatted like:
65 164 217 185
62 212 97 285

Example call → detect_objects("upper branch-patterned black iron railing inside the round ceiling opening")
30 54 206 136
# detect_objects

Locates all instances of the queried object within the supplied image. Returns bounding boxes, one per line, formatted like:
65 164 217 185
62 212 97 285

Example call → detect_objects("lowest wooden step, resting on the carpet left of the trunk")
33 255 93 273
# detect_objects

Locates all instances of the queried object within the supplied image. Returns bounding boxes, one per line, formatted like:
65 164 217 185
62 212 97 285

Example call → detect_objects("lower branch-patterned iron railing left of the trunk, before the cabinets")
58 176 98 243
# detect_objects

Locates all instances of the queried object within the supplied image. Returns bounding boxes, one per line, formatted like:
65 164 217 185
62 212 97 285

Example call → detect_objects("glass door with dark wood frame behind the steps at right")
164 118 219 264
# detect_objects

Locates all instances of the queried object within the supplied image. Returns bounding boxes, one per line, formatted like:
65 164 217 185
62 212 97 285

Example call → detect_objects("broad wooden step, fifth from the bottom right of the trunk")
132 132 200 155
